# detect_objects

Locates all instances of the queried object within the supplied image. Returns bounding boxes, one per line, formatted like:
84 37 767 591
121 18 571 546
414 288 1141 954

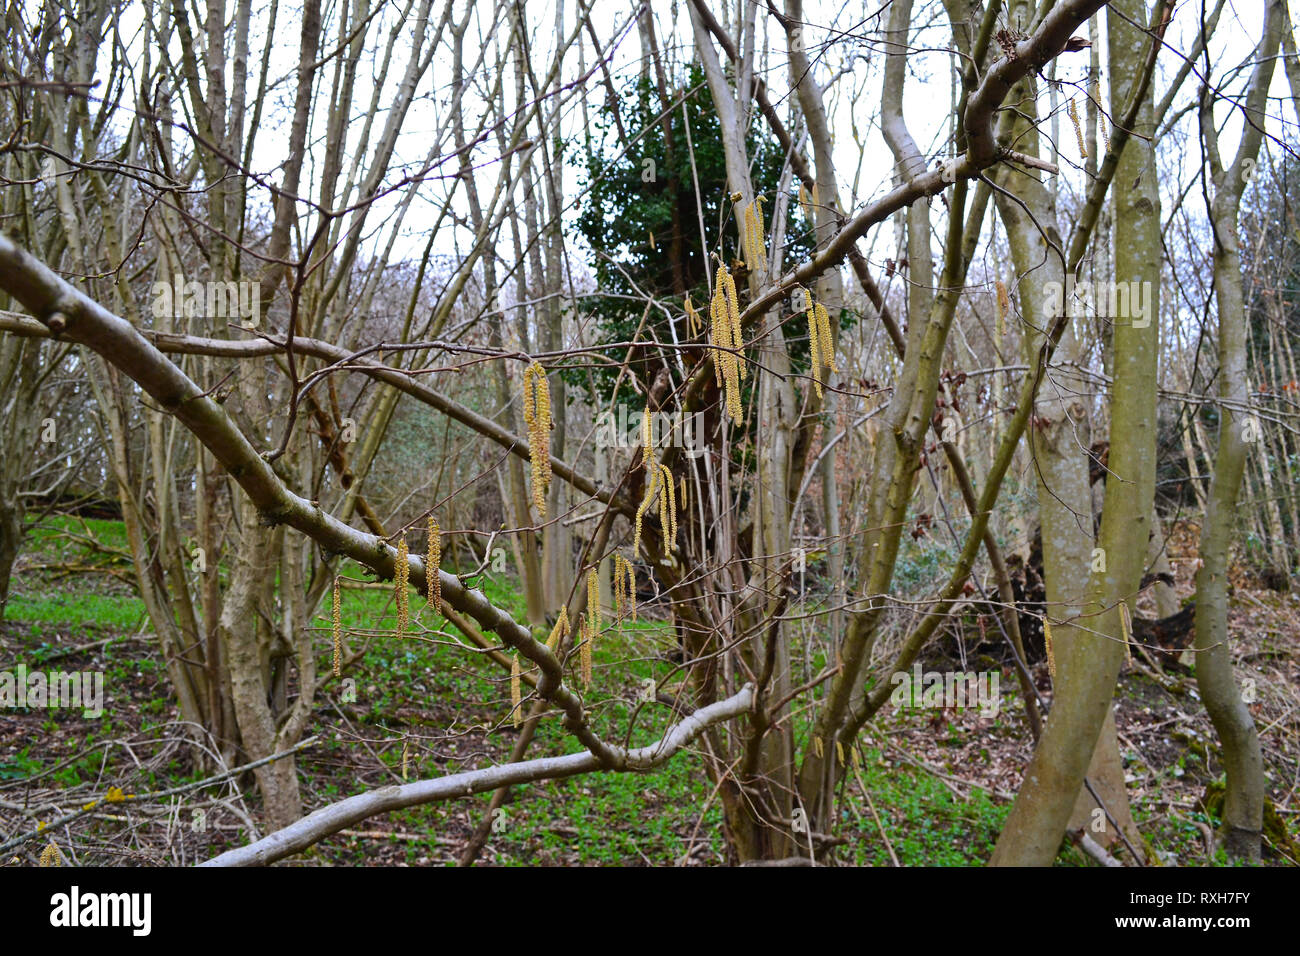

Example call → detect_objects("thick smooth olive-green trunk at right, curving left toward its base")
991 0 1165 866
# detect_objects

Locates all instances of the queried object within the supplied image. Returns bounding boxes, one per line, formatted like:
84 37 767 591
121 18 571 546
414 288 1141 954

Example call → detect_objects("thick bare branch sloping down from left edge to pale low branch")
0 235 628 769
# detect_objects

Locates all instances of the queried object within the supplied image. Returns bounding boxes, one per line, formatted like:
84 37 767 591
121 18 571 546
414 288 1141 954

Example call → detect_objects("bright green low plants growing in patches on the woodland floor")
0 518 1029 866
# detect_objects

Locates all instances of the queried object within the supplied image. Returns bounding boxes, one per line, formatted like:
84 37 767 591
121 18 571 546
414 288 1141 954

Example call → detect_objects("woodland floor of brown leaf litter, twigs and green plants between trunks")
0 519 1300 866
